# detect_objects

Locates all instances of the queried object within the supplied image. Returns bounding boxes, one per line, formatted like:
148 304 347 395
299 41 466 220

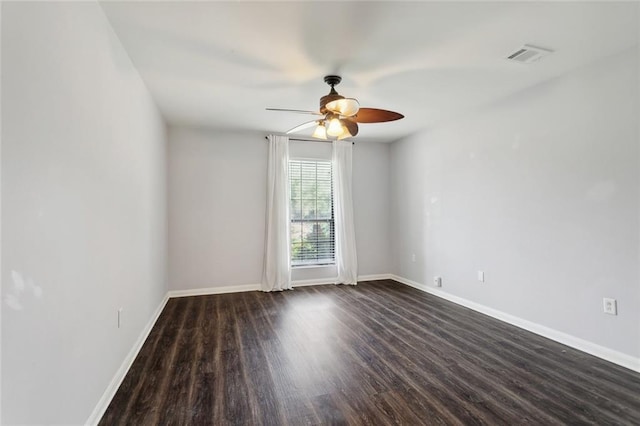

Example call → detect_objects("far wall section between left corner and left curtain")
168 128 267 290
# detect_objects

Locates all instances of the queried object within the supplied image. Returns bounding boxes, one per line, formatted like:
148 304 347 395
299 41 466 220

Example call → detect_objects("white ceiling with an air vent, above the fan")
102 1 640 145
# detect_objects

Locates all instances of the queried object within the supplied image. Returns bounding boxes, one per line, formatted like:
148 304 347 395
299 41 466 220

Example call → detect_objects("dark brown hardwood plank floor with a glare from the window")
100 281 640 425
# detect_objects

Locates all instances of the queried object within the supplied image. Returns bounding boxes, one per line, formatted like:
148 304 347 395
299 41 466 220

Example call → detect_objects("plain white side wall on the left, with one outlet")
2 2 166 424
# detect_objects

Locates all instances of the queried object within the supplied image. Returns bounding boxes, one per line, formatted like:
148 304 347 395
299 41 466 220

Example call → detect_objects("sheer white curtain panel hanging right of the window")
332 141 358 285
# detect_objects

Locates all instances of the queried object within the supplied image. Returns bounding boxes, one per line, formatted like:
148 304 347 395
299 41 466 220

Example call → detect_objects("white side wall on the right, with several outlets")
391 50 640 357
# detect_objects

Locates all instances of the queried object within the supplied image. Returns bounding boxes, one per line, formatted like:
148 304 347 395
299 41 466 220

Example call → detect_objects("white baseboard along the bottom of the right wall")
391 275 640 372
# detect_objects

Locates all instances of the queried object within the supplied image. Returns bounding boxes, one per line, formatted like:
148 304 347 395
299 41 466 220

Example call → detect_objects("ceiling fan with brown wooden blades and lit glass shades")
267 75 404 139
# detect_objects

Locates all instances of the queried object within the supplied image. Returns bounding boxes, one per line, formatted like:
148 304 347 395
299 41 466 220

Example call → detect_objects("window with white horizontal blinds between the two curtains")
289 160 335 266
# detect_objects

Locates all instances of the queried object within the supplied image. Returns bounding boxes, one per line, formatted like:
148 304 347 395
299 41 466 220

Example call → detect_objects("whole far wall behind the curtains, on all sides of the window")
169 127 391 290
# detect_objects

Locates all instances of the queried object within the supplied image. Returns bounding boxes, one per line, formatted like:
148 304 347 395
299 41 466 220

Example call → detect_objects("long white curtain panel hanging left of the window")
262 135 291 291
